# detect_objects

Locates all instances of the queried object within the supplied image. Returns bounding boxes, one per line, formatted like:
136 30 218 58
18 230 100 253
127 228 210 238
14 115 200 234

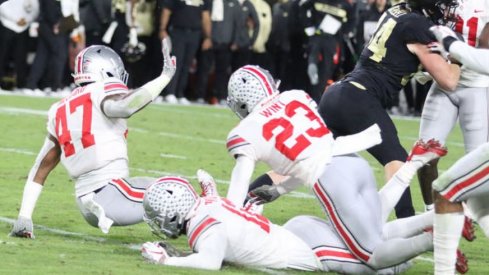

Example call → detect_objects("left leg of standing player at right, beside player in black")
418 83 458 209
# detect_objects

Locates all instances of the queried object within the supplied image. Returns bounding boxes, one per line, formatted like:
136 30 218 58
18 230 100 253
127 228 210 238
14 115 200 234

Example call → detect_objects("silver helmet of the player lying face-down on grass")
143 177 199 239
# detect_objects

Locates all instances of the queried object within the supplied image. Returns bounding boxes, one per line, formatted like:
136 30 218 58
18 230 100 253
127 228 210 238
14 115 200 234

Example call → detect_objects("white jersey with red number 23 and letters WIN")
226 90 334 188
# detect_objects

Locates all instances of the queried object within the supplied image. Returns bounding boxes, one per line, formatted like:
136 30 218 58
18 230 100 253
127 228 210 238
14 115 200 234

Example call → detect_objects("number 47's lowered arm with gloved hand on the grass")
10 135 61 238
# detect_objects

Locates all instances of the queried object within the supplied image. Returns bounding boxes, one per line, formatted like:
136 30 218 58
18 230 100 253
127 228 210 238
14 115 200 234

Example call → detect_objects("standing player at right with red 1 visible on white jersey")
418 0 489 216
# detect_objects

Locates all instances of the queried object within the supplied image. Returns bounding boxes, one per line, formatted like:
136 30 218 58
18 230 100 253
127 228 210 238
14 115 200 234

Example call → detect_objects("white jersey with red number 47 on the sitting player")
47 78 128 196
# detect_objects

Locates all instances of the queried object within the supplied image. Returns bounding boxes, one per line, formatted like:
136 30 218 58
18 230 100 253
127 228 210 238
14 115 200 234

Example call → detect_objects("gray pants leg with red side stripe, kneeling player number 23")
313 155 433 270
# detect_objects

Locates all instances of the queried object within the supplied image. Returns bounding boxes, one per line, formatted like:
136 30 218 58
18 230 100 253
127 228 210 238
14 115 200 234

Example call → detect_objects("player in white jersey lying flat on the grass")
141 170 416 274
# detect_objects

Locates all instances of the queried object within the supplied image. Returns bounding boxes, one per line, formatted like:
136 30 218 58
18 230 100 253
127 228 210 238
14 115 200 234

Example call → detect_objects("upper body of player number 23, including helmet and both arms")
226 65 381 206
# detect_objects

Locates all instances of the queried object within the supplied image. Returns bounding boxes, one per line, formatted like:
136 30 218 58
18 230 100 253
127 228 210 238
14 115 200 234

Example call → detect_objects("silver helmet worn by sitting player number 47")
72 45 129 85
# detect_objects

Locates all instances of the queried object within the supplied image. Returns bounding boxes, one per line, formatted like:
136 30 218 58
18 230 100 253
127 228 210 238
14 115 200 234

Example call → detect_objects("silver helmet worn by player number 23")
227 65 278 119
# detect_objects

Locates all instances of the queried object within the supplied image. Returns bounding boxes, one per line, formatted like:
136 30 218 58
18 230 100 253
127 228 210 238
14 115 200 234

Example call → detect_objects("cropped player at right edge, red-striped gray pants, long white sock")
431 24 489 274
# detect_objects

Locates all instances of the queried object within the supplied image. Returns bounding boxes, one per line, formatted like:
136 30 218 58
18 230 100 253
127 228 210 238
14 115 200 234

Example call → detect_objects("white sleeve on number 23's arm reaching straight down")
227 155 255 207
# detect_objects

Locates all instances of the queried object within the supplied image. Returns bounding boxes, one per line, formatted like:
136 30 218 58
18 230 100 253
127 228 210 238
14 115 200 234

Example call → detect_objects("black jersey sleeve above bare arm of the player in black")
403 14 436 44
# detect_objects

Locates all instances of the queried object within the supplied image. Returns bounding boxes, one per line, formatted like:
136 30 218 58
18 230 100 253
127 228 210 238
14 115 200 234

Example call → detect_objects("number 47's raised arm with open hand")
102 37 177 118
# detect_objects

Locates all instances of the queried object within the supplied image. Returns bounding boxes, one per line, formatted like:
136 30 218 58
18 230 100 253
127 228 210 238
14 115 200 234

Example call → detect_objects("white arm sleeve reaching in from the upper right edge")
450 41 489 75
